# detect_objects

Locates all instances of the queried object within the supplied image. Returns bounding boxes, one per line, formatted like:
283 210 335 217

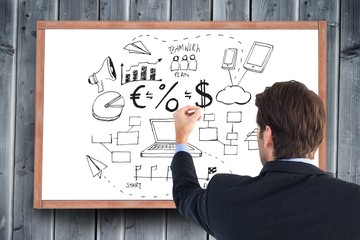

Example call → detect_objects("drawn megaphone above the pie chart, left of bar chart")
88 57 116 93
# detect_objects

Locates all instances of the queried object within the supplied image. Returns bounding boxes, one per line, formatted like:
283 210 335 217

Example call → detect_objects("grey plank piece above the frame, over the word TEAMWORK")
171 0 211 21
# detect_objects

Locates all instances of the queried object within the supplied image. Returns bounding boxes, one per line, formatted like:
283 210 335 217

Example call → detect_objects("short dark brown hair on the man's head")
255 81 325 159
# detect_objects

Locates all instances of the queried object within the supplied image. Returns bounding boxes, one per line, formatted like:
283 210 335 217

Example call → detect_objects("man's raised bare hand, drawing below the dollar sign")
174 106 201 143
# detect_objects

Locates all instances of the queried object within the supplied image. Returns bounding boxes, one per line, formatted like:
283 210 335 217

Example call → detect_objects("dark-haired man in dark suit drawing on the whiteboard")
171 81 360 240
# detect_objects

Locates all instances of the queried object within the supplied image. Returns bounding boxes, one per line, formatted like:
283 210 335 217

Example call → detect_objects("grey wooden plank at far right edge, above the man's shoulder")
338 0 360 184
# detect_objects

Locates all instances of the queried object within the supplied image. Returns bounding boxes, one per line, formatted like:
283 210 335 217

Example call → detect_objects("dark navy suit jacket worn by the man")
171 152 360 240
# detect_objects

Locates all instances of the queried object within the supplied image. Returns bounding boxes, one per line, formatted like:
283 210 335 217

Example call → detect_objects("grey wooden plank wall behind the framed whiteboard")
0 0 360 240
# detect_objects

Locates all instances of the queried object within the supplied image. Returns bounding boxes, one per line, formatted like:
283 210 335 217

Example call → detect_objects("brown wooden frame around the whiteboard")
34 21 327 208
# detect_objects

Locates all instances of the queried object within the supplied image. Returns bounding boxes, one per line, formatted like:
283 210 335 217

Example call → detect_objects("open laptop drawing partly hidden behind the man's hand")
140 118 202 158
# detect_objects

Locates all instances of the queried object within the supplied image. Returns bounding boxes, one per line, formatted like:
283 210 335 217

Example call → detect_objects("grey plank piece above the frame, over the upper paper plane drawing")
130 0 170 21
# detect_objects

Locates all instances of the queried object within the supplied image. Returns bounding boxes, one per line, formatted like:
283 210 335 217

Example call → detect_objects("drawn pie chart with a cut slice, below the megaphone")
92 91 125 121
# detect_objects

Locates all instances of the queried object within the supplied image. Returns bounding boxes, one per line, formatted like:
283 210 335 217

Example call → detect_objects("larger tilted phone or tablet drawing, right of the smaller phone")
244 42 274 73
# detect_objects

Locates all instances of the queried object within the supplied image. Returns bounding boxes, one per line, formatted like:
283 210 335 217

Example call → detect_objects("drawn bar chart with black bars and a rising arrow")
121 58 162 85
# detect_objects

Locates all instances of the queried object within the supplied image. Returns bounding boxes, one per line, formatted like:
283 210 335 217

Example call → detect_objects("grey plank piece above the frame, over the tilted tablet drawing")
251 0 298 21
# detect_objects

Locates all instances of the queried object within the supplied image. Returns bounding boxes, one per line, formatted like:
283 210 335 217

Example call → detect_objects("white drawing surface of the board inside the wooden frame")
38 23 328 207
